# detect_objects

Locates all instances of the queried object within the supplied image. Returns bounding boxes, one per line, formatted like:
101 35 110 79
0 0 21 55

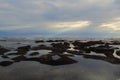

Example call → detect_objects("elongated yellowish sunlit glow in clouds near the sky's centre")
47 21 91 36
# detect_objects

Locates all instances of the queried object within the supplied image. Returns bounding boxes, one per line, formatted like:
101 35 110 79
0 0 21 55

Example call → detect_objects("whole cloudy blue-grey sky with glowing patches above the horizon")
0 0 120 38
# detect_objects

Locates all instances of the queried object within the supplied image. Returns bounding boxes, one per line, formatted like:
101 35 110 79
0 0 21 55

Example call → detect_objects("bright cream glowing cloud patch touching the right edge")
99 18 120 31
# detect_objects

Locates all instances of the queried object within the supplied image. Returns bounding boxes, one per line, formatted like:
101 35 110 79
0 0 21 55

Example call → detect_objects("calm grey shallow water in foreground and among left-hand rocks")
0 39 120 80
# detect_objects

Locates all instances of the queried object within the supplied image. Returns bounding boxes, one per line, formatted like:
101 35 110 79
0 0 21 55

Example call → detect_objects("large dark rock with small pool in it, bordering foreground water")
27 54 77 66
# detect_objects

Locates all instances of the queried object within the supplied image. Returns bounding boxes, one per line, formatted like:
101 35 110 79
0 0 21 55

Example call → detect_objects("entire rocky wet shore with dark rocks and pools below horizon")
0 39 120 80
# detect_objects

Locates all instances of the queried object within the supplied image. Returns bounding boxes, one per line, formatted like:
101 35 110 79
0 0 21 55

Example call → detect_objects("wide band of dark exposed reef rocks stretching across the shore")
0 40 120 66
